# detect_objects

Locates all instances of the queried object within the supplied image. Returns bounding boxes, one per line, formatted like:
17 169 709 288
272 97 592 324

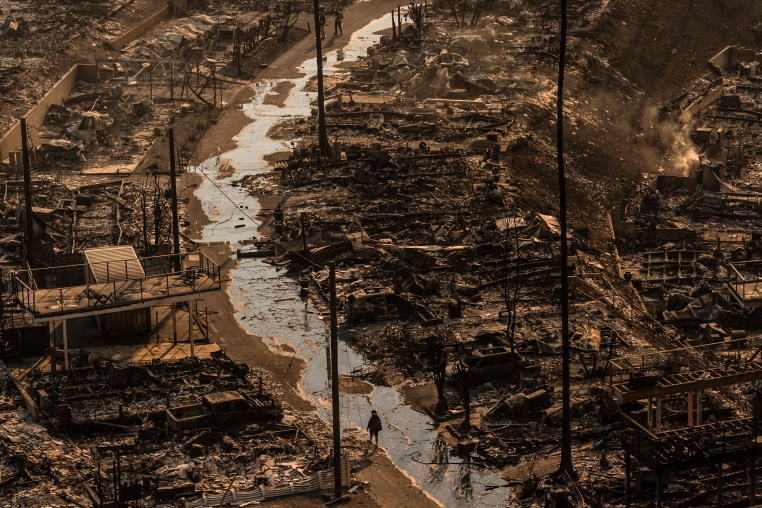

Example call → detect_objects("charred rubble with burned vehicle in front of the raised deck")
0 348 366 505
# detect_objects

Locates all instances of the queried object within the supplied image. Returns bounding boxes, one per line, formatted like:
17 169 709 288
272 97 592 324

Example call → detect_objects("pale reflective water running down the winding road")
191 14 509 506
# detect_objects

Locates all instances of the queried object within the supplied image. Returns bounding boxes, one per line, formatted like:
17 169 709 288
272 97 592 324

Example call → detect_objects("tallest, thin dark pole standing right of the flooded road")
556 0 576 479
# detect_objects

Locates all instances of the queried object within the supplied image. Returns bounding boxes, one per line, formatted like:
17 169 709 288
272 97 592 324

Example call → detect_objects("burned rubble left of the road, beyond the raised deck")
0 0 296 266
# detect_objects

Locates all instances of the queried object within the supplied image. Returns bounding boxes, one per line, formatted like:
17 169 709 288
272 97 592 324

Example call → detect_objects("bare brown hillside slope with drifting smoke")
513 0 762 247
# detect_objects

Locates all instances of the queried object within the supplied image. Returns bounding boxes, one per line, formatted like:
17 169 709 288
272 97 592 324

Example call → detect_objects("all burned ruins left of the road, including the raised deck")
0 0 349 506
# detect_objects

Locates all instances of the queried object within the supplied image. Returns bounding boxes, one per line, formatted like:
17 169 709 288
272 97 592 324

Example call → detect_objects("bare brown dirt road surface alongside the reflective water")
183 1 439 508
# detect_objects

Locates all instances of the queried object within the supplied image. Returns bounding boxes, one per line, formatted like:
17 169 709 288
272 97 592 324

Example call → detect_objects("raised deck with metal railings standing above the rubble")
15 254 221 323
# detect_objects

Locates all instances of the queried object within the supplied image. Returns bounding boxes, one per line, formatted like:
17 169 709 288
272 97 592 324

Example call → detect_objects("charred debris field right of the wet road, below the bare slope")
238 18 762 506
